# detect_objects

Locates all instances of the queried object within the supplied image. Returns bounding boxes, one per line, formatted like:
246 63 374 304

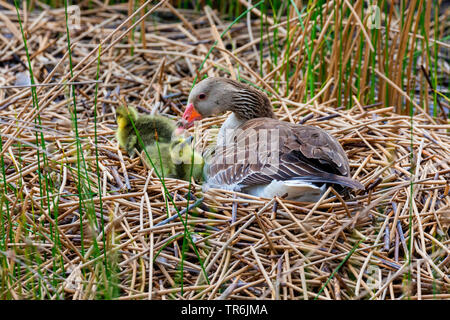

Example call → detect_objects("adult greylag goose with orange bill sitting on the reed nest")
183 78 364 201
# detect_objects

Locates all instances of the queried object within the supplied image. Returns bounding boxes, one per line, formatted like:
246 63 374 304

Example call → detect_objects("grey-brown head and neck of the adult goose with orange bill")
183 77 275 127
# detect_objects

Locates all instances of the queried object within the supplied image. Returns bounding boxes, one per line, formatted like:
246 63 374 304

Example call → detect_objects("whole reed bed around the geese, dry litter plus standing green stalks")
0 0 450 300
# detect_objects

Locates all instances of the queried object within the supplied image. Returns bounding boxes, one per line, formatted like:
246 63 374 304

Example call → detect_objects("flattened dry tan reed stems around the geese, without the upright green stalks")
0 1 450 300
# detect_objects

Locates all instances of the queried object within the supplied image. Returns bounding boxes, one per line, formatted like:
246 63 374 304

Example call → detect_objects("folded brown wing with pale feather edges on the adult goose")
206 118 364 189
